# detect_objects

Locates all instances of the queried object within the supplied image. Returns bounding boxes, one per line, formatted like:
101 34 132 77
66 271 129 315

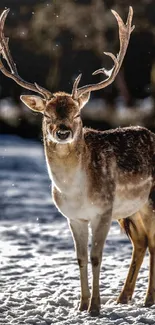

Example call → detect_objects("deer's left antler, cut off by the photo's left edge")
0 9 52 100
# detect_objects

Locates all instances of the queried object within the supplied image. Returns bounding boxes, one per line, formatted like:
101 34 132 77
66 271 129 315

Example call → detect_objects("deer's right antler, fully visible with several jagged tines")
73 7 135 98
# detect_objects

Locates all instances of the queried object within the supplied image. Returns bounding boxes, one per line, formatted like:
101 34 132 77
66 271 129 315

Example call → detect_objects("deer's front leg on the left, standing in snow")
69 220 90 311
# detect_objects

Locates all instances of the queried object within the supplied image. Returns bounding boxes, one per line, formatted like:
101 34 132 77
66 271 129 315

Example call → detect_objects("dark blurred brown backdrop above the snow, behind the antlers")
0 0 155 139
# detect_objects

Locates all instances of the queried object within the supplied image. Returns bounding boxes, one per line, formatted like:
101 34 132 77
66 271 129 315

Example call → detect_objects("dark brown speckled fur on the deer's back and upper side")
85 127 155 175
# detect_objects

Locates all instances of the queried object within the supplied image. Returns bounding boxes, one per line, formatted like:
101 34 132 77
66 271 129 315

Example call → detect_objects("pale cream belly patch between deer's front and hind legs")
112 178 151 219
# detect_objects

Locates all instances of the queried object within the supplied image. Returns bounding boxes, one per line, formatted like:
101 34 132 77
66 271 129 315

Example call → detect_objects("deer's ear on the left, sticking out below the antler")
20 95 46 113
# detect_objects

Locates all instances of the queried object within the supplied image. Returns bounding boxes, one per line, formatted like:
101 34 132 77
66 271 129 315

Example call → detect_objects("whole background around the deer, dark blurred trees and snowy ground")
0 0 155 318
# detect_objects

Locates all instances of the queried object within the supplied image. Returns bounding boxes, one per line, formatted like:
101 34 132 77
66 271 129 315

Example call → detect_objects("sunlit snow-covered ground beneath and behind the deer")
0 137 155 325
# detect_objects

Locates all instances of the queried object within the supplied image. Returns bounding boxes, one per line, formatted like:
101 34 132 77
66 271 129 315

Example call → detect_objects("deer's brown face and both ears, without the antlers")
21 92 90 144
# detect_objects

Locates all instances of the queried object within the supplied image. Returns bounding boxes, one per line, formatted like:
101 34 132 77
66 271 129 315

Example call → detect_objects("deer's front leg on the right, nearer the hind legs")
89 209 111 316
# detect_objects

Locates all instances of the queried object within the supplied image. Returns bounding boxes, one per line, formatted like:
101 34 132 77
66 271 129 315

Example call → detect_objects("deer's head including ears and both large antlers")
0 7 134 143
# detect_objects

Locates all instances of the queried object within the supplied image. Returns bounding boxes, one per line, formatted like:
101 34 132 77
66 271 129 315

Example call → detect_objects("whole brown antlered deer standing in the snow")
0 7 155 316
